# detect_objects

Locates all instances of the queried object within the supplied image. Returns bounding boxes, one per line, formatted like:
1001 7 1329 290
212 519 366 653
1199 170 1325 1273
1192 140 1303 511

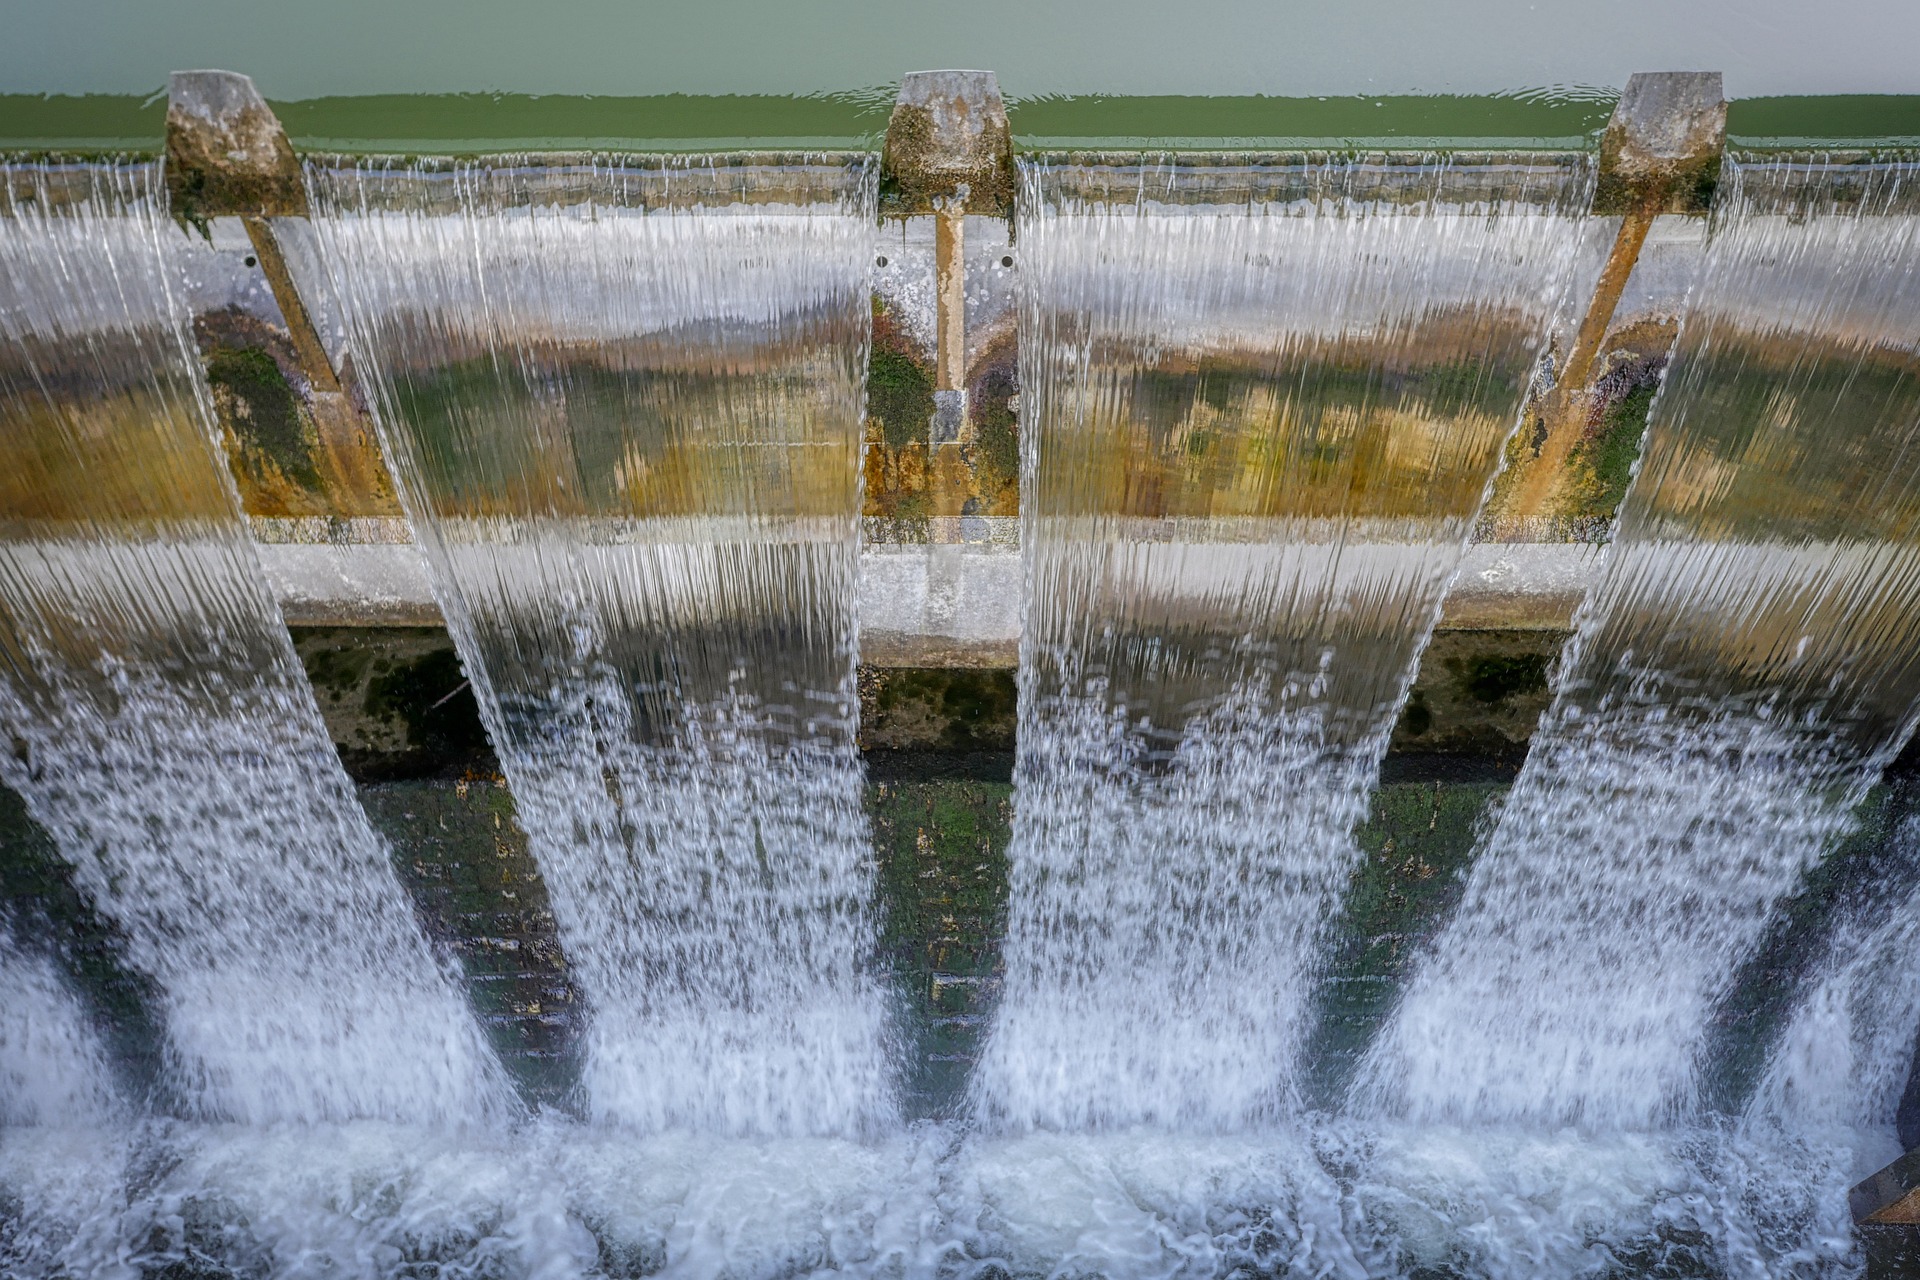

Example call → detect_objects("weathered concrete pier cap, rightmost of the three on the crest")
1594 71 1726 213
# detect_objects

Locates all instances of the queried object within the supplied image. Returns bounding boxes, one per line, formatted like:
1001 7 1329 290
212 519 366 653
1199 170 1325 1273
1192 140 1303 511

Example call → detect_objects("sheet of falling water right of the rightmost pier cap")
1361 161 1920 1128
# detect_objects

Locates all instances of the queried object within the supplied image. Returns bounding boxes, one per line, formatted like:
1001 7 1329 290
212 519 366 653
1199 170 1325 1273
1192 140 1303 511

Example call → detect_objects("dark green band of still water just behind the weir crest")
0 86 1920 155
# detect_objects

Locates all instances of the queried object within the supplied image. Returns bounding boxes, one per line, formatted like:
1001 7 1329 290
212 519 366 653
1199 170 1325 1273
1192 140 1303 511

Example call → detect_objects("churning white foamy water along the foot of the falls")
0 1121 1853 1280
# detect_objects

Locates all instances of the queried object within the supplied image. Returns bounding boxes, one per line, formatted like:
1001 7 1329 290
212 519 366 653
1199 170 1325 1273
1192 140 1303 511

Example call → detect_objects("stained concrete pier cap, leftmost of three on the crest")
167 71 307 226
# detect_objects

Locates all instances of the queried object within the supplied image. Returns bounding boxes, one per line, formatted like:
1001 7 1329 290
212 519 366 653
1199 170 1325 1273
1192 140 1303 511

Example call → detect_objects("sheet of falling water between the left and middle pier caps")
309 161 893 1134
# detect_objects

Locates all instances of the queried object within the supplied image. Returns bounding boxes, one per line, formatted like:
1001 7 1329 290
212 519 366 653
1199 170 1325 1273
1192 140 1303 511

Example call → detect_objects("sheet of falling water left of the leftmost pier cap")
0 165 492 1123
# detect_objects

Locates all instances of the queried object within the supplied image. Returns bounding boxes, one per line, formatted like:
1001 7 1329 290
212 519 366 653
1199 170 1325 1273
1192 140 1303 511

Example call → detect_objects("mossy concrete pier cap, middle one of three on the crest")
879 71 1014 217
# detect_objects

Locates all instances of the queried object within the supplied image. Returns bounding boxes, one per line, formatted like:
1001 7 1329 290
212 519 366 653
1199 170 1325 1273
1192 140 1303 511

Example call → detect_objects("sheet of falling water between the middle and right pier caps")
975 157 1590 1128
